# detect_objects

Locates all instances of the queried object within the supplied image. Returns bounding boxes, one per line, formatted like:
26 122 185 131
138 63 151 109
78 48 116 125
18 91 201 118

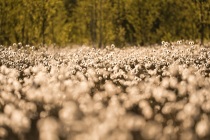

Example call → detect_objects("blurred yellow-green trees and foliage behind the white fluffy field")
0 0 210 47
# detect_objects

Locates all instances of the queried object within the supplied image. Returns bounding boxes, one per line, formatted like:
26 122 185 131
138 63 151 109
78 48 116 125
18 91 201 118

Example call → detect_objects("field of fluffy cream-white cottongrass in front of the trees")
0 41 210 140
